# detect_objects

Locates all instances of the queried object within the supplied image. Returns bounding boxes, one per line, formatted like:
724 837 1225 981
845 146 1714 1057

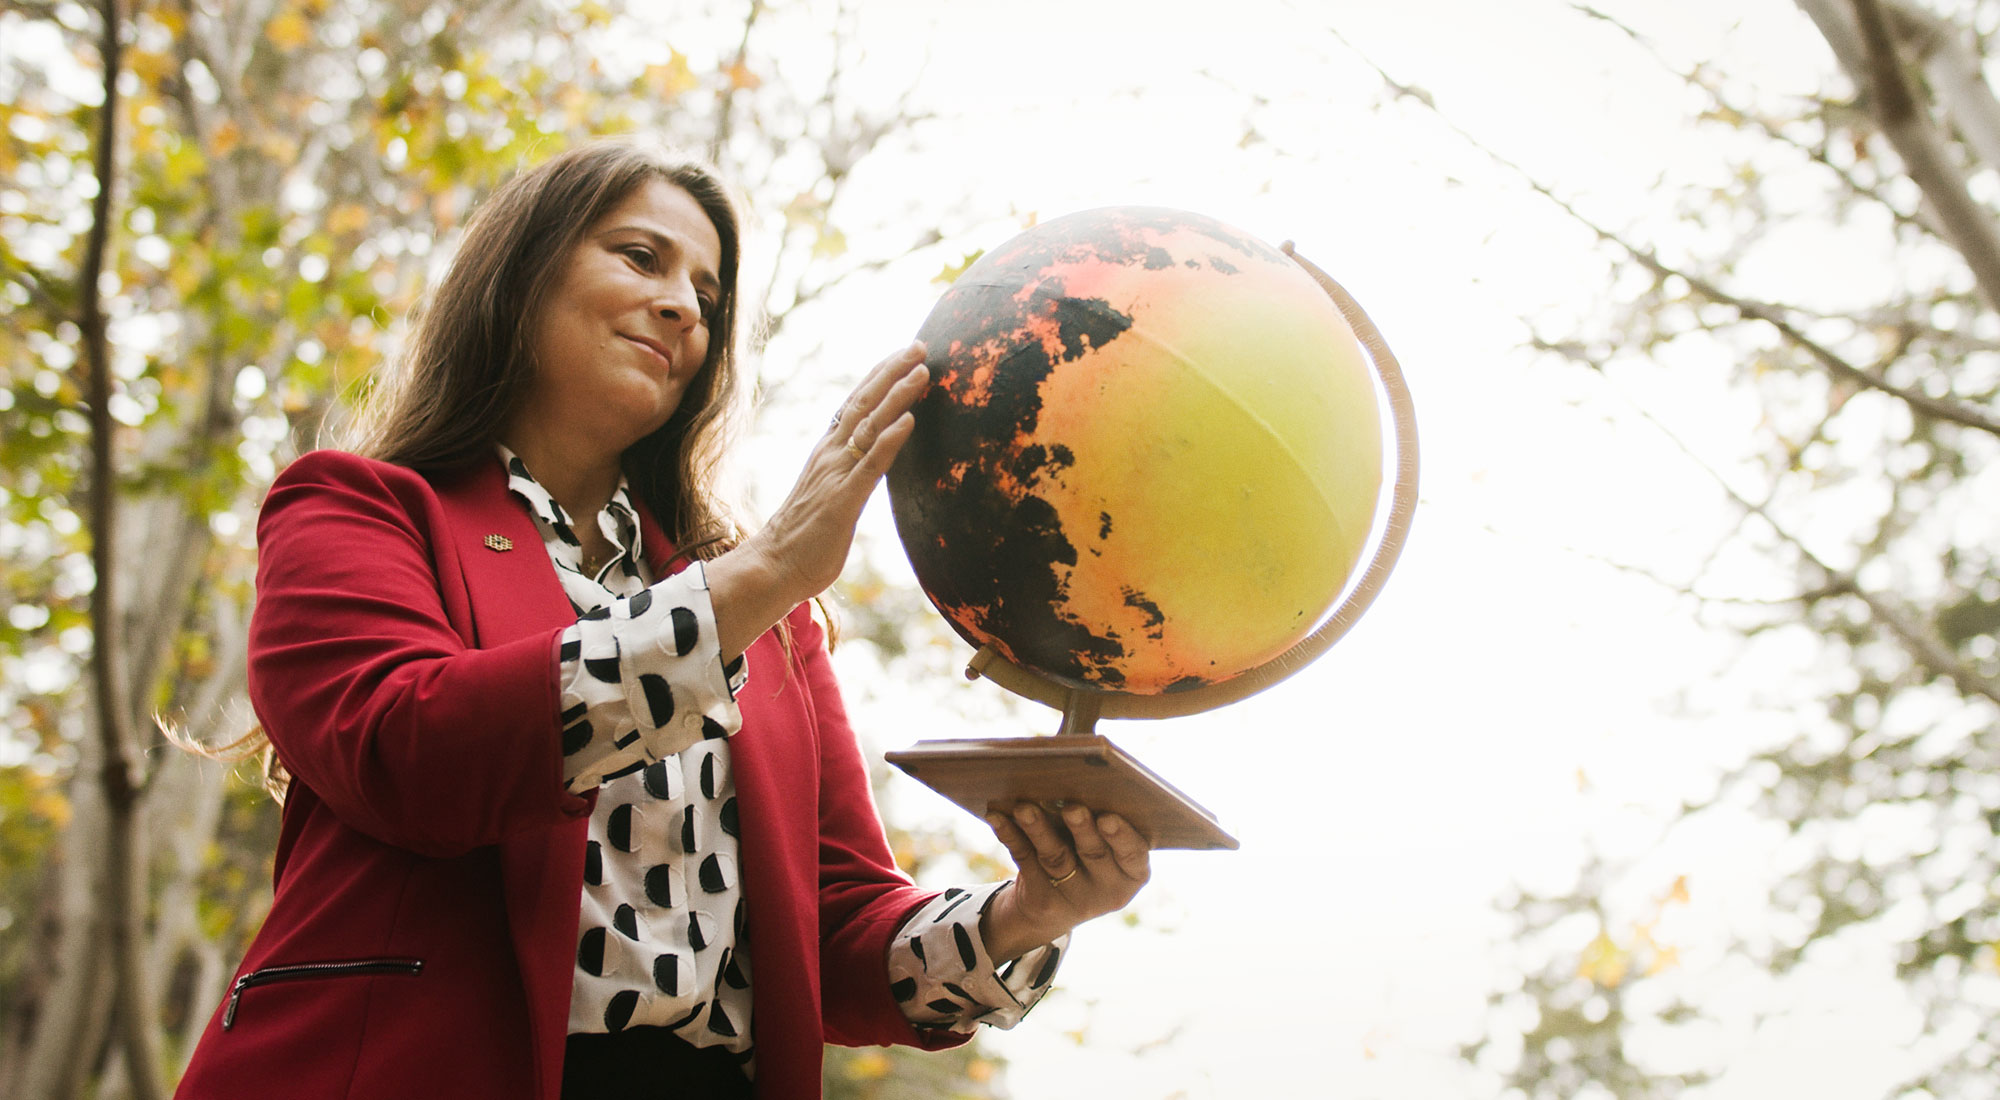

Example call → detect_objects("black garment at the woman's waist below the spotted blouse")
562 1026 750 1100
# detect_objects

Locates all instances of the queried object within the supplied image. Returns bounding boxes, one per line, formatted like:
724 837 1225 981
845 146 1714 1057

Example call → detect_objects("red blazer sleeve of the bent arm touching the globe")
250 450 590 856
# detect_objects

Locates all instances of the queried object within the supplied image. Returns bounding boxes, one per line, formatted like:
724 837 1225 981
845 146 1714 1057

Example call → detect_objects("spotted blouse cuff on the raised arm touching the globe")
558 562 748 794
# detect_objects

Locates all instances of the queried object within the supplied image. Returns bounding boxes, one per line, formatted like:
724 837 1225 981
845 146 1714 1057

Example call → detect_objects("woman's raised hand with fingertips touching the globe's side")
704 344 930 660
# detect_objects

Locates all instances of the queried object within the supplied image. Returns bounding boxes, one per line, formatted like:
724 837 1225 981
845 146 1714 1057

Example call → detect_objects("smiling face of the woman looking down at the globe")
516 180 724 452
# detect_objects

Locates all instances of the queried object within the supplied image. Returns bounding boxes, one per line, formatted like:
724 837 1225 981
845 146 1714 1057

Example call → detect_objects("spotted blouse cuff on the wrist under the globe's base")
888 882 1070 1032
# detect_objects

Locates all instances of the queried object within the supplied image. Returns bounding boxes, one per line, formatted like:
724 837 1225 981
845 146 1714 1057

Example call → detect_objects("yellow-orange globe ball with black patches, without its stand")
888 206 1382 694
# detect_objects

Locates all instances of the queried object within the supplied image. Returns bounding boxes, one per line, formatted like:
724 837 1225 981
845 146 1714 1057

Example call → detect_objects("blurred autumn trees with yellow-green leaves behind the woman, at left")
0 0 996 1100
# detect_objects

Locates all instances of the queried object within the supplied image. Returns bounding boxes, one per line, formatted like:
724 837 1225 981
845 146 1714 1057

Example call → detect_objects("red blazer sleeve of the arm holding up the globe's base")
792 604 970 1050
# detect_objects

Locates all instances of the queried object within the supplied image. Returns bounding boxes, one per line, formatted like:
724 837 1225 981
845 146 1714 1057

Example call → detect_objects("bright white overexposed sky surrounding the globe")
716 0 1916 1100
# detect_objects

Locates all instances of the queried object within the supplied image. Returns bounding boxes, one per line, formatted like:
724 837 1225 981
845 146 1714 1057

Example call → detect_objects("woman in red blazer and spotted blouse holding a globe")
180 144 1146 1100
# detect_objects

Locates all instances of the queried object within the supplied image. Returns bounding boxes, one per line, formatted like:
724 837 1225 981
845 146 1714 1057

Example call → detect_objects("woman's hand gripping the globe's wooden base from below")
980 802 1152 962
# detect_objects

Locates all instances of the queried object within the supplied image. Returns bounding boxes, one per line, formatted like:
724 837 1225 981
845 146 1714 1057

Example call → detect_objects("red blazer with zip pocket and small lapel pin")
178 450 962 1100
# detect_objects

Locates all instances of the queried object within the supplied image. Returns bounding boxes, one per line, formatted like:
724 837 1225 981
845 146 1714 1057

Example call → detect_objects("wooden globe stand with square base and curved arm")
886 242 1418 848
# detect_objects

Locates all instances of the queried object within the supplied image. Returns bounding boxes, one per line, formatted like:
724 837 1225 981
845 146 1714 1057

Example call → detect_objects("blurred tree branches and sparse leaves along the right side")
1392 0 2000 1098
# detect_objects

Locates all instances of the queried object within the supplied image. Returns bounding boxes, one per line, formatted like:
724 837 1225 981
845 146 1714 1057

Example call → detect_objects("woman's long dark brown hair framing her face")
344 140 742 558
